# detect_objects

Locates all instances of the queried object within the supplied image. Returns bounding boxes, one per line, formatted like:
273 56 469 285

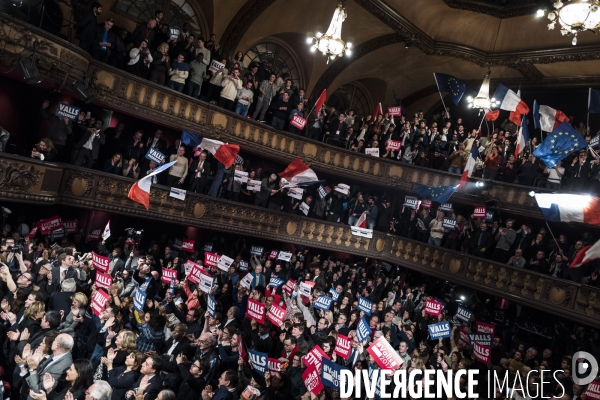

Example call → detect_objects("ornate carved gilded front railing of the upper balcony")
0 15 541 218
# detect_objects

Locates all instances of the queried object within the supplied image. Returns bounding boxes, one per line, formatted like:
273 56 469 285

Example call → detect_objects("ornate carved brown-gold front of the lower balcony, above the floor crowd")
0 154 600 328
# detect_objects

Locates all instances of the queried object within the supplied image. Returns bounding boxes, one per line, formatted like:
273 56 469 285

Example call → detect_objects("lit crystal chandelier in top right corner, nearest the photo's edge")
548 0 600 46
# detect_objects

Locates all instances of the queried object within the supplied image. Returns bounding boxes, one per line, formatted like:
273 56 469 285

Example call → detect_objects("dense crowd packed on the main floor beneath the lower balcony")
0 218 599 400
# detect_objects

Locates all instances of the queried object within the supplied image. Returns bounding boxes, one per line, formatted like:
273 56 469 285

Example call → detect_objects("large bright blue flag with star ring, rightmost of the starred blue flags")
533 121 587 168
